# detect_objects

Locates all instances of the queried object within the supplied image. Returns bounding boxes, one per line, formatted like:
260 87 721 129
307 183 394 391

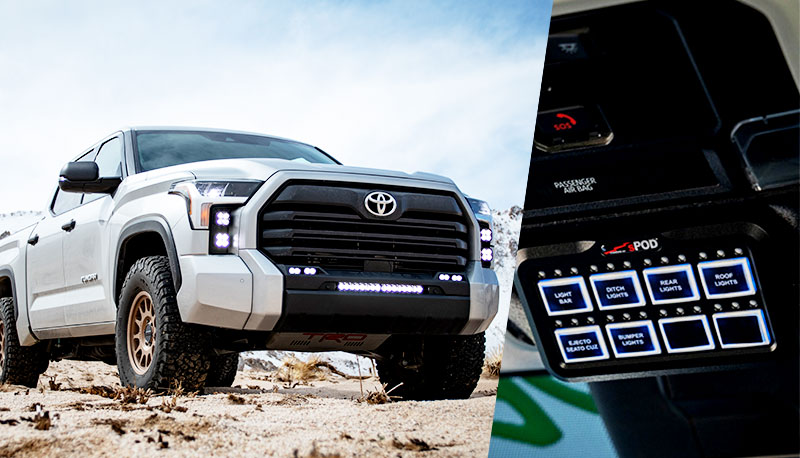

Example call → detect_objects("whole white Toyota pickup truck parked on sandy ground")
0 127 498 399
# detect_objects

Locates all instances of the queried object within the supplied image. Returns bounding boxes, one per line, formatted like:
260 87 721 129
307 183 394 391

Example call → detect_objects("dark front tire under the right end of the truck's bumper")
377 333 486 401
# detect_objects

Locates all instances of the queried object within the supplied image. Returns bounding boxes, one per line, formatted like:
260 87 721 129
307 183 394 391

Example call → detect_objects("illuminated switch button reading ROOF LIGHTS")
697 258 756 299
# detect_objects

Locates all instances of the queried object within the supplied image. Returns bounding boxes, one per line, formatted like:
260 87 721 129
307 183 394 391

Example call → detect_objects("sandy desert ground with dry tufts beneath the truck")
0 361 497 458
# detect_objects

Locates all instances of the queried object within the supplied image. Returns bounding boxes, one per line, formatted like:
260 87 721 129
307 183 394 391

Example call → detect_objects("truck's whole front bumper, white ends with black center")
178 249 499 334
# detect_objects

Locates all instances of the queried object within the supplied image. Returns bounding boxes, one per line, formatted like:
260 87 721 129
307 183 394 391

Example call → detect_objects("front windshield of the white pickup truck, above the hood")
136 130 336 172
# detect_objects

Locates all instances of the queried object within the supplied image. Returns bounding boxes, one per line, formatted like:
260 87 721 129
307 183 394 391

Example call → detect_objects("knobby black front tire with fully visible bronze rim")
115 256 211 391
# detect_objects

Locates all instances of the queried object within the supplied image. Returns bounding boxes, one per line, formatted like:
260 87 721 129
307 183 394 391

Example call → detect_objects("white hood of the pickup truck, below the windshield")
138 159 454 185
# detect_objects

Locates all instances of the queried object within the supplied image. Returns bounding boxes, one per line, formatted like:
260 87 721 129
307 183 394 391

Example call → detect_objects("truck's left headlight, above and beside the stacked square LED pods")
169 180 263 229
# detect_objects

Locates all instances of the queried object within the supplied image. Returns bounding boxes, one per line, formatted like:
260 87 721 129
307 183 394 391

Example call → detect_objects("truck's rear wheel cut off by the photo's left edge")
0 297 50 388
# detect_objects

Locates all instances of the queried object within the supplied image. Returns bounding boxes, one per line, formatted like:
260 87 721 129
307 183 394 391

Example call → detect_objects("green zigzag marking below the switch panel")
492 375 597 446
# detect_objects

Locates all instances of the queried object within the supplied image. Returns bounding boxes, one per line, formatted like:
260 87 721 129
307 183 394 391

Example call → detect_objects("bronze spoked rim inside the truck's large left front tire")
128 291 156 375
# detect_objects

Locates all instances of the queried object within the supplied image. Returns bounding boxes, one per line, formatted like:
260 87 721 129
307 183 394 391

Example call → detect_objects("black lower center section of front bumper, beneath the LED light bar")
274 290 470 334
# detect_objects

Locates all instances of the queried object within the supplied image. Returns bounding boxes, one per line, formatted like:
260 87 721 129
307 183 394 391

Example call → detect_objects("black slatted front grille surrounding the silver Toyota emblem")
259 183 469 273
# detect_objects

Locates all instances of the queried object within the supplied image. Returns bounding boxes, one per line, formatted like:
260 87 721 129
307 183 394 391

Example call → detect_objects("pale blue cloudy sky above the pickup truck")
0 0 551 213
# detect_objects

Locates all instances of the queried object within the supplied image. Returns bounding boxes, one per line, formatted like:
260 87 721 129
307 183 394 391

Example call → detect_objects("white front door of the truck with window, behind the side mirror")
63 135 123 326
